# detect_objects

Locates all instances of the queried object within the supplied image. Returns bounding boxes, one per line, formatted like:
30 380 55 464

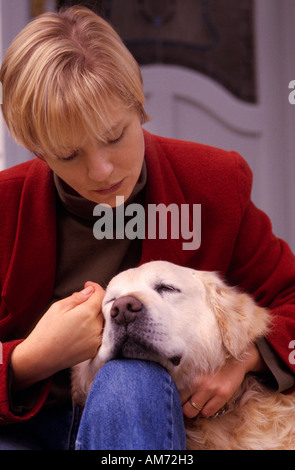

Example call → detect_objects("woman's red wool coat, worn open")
0 132 295 423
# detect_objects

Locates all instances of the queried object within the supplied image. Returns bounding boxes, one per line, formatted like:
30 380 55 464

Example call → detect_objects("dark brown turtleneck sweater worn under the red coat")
46 163 147 406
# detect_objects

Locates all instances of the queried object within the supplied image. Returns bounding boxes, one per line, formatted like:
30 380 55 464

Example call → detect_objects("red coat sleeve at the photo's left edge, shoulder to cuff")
0 161 51 425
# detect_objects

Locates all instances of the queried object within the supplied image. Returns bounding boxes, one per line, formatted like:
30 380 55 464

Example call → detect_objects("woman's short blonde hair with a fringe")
0 7 148 156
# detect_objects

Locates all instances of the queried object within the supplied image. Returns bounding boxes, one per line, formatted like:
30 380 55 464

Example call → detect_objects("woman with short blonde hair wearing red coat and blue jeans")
0 7 295 449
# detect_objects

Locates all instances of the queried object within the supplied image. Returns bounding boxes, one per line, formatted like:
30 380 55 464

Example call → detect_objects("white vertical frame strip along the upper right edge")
256 0 295 250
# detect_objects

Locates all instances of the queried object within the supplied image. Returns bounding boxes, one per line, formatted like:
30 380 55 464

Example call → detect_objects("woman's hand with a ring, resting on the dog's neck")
180 344 265 418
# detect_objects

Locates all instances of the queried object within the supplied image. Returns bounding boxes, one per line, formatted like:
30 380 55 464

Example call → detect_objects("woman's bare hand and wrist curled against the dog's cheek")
11 282 104 391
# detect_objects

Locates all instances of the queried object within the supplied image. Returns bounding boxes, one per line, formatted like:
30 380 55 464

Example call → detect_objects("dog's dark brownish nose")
110 295 143 325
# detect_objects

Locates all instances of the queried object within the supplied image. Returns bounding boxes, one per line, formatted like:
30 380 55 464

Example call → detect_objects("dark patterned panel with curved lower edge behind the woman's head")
58 0 256 102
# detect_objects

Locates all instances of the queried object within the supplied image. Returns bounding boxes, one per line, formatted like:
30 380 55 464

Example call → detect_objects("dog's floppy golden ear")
207 281 269 359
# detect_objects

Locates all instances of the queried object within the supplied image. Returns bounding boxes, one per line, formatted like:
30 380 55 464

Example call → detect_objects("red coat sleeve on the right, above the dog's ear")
229 157 295 386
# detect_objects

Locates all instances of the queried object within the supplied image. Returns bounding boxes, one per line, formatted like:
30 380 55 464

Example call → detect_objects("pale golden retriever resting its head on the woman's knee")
73 261 295 450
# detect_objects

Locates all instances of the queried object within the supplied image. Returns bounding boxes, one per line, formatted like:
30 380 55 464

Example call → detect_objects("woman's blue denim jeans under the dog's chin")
0 359 186 450
